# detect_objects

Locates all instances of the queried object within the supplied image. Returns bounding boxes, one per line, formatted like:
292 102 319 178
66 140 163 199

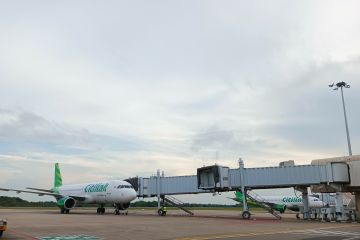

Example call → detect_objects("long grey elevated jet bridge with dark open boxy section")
131 156 360 221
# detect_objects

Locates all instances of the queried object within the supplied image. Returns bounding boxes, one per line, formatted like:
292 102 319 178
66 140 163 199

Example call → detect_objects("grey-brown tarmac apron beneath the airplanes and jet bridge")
0 208 360 240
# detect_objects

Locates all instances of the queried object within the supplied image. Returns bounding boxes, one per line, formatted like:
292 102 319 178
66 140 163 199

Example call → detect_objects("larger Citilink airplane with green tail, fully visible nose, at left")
0 163 137 215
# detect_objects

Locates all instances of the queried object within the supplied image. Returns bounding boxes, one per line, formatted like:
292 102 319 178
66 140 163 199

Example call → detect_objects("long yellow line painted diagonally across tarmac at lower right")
176 224 359 240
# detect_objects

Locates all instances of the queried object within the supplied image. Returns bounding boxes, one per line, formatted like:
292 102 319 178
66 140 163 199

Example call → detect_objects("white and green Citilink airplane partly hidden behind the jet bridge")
230 191 326 213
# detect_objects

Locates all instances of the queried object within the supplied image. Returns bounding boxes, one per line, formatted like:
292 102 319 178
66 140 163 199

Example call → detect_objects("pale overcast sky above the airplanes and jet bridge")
0 0 360 203
